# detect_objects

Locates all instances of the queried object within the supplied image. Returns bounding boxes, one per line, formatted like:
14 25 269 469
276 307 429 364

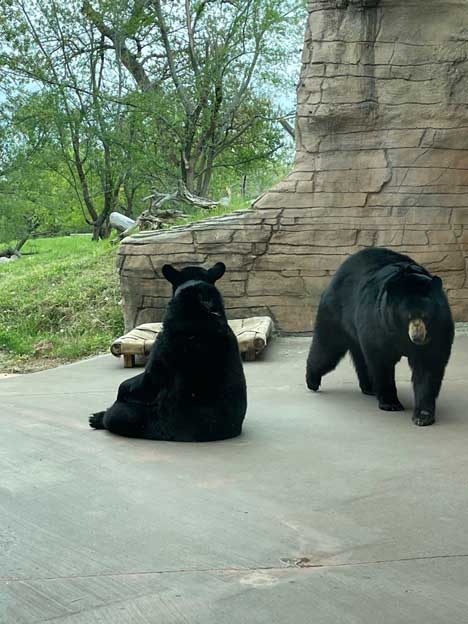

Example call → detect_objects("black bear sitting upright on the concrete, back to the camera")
89 262 247 442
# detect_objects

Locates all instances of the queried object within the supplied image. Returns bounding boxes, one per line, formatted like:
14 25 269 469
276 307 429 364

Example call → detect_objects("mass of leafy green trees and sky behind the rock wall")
0 0 305 240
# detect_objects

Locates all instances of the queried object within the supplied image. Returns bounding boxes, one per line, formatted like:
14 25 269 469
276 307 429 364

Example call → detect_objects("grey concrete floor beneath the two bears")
0 337 468 624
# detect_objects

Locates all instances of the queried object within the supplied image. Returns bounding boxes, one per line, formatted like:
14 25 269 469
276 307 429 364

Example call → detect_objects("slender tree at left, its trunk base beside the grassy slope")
0 0 141 239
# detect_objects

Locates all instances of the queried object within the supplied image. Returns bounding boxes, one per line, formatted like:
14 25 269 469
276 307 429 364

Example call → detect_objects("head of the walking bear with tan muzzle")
384 264 446 346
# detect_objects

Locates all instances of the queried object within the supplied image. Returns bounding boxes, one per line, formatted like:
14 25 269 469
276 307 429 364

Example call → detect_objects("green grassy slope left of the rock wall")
0 236 123 372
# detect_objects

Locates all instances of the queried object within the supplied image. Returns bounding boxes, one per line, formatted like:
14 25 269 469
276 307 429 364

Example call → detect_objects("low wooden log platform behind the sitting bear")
111 316 273 368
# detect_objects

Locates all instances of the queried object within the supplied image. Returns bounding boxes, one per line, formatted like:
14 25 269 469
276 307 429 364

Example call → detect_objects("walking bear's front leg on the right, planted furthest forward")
409 360 445 427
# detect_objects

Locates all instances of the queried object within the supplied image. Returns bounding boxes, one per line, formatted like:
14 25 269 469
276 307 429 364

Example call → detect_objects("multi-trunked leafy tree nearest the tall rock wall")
83 0 302 195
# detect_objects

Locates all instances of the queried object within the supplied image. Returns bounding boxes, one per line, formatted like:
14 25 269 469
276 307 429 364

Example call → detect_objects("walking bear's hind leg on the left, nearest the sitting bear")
306 309 348 392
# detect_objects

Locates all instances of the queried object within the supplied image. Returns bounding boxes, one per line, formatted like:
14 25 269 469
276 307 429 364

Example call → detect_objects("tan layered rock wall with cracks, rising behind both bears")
119 0 468 332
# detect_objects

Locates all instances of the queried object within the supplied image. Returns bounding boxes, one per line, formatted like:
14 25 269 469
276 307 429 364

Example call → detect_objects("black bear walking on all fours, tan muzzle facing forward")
306 248 454 426
